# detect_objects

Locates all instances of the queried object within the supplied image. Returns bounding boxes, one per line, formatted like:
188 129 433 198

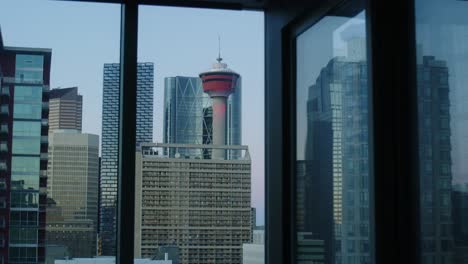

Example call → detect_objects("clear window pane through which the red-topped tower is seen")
135 6 264 264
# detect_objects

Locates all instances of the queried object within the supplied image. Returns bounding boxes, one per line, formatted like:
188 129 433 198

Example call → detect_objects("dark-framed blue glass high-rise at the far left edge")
0 28 52 263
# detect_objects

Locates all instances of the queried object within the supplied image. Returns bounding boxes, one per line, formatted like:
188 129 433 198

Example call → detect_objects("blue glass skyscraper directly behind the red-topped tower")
163 76 241 157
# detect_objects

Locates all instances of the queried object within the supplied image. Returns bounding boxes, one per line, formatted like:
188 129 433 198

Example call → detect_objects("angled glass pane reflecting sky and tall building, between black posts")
295 5 374 264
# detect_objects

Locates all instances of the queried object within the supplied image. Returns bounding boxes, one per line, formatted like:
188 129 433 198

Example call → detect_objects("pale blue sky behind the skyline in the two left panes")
0 0 264 224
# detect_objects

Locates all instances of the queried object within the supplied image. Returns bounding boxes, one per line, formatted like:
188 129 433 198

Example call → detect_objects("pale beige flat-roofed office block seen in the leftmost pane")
46 130 99 257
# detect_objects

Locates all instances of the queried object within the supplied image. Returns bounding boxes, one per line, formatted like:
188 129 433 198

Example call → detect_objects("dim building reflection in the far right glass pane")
418 56 453 264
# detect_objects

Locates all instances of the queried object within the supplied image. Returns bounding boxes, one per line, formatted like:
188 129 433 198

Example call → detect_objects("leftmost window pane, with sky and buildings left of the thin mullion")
0 0 121 264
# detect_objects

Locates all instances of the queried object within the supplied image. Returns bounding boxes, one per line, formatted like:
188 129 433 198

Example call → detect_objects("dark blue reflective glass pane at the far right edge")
415 0 468 264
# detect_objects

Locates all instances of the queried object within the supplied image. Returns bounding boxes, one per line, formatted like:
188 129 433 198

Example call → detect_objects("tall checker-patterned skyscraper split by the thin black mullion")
99 62 154 256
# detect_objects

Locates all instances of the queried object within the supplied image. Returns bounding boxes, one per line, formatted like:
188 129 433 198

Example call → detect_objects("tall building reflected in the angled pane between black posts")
302 56 371 264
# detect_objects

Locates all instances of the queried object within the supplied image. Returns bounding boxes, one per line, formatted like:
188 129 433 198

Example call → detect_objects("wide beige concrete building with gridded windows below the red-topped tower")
135 144 251 264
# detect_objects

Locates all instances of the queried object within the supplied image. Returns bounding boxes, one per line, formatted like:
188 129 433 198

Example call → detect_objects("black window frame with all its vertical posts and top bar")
51 0 420 264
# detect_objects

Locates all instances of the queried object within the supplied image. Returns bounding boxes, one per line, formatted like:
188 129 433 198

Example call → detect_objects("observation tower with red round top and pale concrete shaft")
200 51 239 159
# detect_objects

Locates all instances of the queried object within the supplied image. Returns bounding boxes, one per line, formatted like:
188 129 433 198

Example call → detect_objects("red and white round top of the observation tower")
200 57 239 97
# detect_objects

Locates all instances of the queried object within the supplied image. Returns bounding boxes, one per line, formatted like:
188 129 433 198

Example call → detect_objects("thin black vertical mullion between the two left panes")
116 1 138 264
